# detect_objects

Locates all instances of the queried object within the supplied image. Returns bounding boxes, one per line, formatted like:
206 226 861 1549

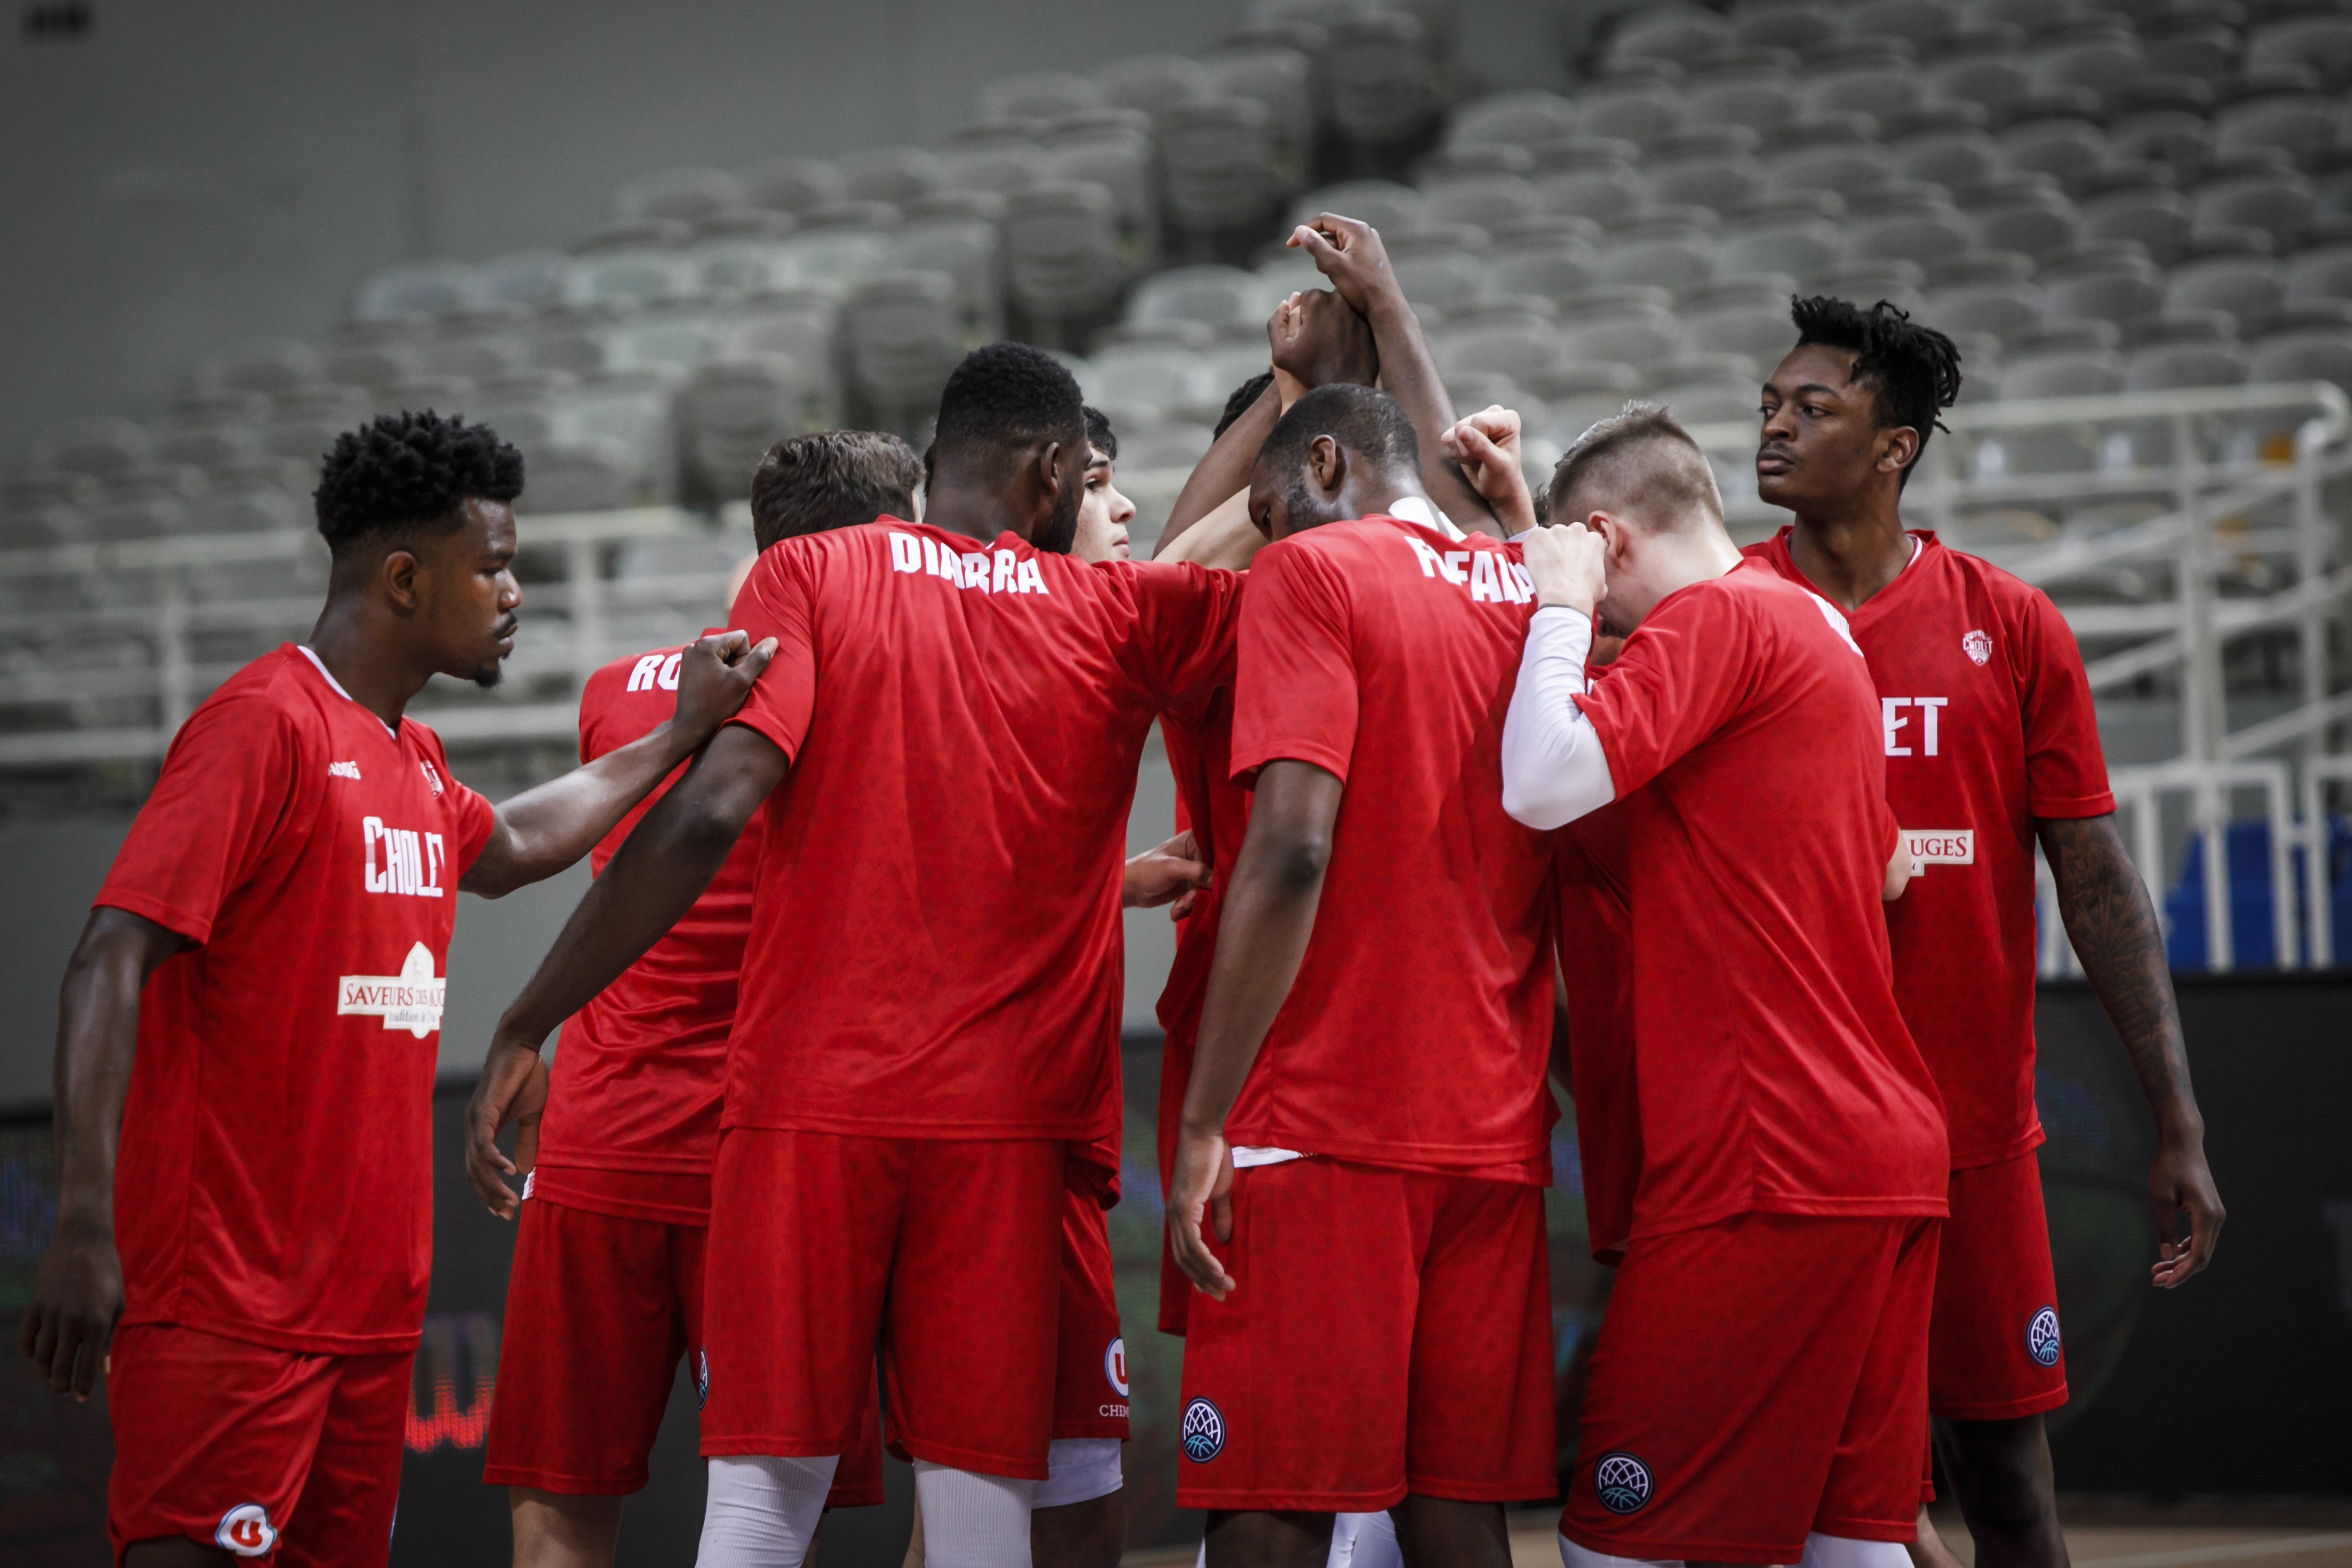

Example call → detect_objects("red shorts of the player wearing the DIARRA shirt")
703 1129 1065 1481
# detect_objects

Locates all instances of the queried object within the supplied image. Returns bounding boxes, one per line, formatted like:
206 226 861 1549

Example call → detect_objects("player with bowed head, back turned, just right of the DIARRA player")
1169 386 1555 1568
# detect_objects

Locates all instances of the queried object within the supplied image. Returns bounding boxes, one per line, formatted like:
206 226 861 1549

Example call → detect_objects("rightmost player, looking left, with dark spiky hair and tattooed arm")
1750 299 2223 1568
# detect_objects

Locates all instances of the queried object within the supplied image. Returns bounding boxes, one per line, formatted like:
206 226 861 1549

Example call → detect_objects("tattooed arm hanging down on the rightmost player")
2034 816 2223 1288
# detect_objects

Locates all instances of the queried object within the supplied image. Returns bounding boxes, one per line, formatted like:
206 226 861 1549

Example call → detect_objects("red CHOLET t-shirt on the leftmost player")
96 644 492 1354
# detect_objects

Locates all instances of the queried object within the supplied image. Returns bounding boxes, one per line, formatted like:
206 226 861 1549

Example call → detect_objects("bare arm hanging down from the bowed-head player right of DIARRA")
1169 762 1345 1300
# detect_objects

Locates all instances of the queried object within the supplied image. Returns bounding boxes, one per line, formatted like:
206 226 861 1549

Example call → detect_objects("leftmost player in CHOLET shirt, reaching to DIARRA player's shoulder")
19 414 771 1568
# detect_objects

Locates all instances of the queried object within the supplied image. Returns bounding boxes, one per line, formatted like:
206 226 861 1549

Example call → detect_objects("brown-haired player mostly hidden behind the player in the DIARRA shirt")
466 430 922 1568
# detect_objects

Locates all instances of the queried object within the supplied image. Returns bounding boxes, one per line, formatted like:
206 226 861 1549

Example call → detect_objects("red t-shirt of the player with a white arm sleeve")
1578 562 1947 1236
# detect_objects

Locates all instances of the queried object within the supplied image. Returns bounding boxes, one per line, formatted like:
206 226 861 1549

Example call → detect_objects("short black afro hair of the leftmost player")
313 409 522 557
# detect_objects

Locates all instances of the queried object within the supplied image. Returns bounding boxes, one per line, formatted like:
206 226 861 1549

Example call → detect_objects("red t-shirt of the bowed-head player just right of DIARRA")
1225 515 1557 1182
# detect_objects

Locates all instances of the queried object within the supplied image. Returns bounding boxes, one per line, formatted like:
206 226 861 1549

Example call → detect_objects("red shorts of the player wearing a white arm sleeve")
1559 1213 1943 1563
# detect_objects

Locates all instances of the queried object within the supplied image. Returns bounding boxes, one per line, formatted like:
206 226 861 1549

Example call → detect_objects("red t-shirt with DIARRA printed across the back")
724 517 1240 1143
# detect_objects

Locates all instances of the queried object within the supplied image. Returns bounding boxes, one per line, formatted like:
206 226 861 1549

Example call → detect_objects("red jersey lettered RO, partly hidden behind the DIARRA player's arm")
532 632 767 1225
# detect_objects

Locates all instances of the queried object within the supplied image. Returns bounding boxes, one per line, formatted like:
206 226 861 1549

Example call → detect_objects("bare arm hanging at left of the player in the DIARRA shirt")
466 724 790 1220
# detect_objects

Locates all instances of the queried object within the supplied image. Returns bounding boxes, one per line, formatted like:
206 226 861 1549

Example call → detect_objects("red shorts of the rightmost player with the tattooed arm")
1926 1154 2065 1420
